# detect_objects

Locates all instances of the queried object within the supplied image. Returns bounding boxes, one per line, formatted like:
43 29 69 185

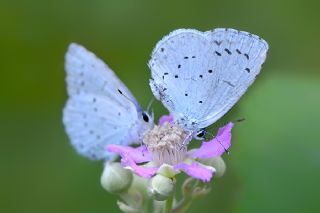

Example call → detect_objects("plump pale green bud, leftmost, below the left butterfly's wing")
100 162 132 193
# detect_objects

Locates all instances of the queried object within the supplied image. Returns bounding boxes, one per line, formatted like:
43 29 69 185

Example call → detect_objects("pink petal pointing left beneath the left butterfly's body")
107 144 152 163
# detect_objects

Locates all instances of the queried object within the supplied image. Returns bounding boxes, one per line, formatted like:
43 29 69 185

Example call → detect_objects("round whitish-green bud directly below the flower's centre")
149 175 175 201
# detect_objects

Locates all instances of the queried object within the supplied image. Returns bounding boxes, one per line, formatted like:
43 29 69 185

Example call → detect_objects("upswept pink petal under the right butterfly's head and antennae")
189 122 233 158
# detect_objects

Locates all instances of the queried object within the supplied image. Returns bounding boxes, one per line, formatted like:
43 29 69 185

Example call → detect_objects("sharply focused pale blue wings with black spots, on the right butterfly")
149 28 268 130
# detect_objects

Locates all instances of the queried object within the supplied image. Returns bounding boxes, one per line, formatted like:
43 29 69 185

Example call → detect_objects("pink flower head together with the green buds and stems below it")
101 117 233 212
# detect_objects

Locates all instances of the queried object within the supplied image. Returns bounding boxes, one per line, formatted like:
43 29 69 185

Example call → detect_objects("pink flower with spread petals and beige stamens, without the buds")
107 116 233 182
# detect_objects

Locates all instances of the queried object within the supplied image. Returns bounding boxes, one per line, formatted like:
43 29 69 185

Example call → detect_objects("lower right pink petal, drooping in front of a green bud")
174 162 215 182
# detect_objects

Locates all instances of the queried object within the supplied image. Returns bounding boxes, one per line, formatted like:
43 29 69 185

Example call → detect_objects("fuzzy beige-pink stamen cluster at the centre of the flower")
143 122 187 165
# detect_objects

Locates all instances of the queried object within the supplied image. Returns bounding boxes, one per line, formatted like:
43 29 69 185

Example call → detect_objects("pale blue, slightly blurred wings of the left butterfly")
63 44 152 160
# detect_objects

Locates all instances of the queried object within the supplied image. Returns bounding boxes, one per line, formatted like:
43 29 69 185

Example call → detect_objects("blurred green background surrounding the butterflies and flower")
0 0 320 213
